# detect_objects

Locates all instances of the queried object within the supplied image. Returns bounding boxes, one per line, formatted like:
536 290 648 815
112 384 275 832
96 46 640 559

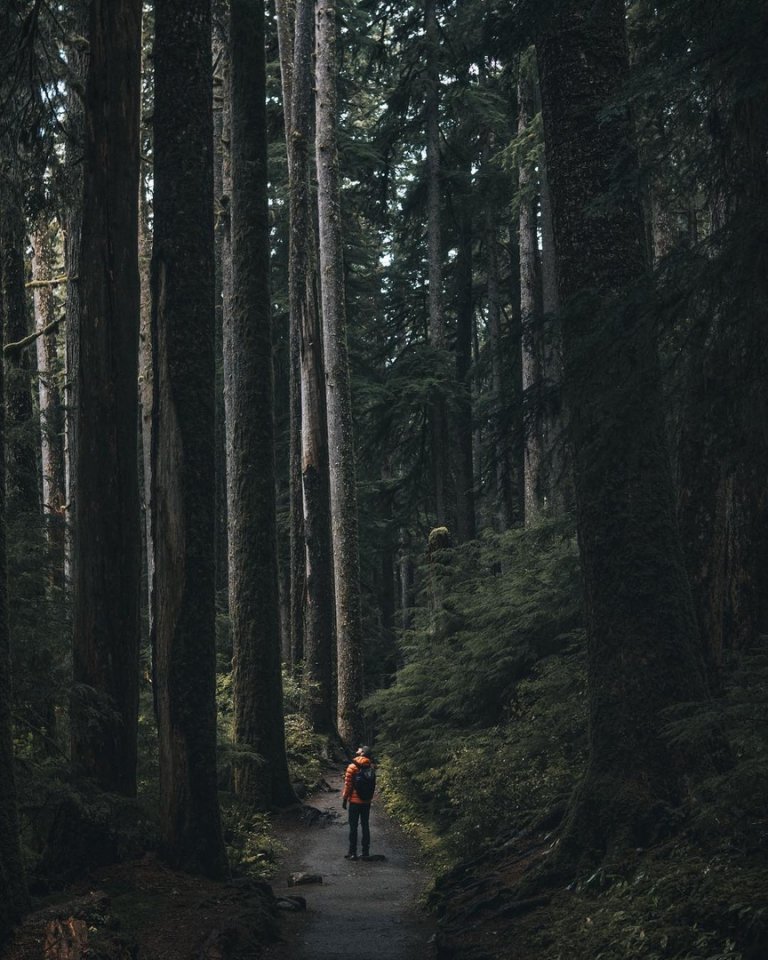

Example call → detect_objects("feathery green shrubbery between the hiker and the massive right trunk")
366 521 586 856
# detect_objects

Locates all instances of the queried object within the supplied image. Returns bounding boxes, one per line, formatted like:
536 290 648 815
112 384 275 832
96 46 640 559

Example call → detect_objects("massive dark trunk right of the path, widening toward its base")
537 0 706 866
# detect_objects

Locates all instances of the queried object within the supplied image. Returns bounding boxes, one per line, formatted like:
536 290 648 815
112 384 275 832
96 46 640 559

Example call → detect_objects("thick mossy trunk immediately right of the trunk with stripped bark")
224 0 296 809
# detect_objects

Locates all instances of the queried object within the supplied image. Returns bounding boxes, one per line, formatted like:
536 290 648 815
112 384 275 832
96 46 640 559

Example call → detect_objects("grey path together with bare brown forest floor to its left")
0 769 435 960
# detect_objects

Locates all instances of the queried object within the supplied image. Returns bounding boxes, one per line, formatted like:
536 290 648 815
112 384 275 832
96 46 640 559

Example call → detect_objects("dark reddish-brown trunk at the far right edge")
680 50 768 682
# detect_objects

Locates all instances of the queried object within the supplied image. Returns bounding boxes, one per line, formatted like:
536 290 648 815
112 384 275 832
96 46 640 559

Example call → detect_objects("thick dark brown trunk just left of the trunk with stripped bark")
71 0 141 795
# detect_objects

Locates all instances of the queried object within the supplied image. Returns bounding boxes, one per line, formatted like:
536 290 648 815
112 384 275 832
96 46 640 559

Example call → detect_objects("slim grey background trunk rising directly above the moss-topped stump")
424 0 451 526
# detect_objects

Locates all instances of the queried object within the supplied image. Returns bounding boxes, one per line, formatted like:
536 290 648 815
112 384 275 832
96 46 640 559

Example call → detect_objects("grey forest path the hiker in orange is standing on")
267 770 435 960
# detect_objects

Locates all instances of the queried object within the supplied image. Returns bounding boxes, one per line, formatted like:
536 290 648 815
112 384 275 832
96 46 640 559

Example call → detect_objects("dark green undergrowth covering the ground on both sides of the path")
7 520 768 960
